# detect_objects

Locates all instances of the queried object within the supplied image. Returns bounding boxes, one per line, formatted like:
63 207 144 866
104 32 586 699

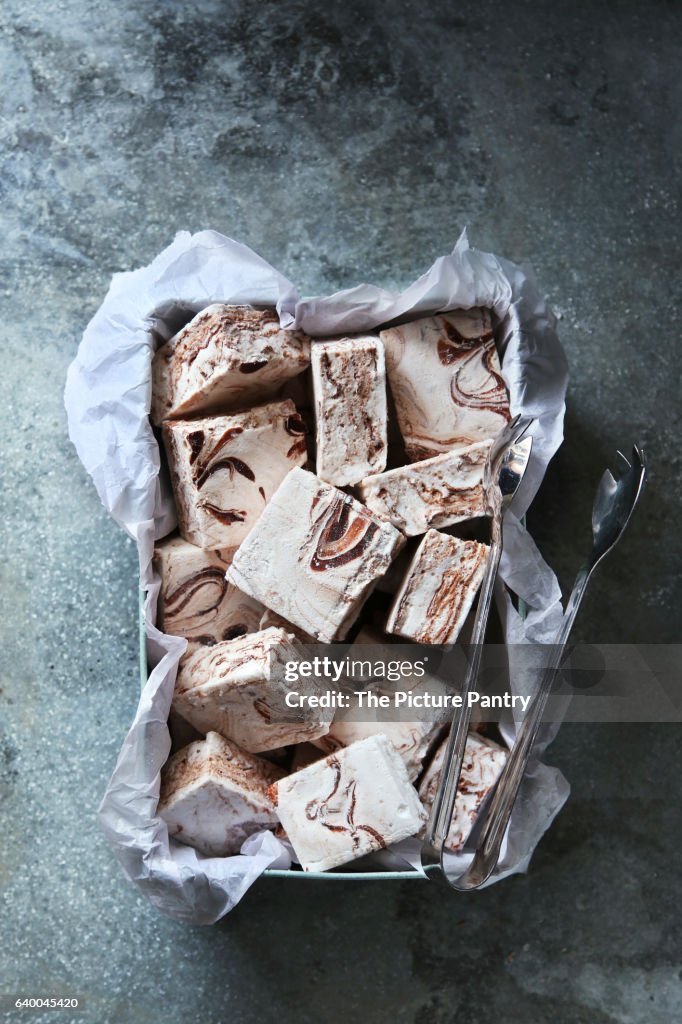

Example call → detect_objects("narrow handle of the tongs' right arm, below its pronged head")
447 566 591 891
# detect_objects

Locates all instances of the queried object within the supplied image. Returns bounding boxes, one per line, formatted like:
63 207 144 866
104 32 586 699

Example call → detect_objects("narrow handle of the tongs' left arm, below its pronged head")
422 517 502 882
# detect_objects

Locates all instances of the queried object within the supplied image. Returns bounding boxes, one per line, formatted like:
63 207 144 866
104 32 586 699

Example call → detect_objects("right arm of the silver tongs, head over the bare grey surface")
449 445 646 891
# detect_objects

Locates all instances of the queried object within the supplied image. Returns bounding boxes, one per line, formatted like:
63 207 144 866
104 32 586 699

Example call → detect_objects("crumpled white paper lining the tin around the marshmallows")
65 231 568 924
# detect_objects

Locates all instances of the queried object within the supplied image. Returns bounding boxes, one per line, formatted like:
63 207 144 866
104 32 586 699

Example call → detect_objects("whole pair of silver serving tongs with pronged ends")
422 417 646 892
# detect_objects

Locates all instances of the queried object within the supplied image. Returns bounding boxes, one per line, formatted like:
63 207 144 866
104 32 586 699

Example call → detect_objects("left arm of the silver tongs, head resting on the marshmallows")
422 416 534 883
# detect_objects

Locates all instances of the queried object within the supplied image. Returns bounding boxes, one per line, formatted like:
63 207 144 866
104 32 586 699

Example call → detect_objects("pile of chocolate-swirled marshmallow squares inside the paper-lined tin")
152 305 509 870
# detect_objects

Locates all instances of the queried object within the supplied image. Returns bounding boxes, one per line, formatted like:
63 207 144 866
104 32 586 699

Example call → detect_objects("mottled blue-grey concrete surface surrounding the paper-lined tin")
0 0 682 1024
